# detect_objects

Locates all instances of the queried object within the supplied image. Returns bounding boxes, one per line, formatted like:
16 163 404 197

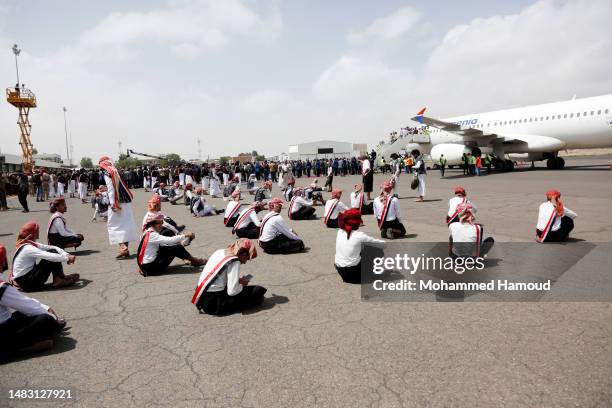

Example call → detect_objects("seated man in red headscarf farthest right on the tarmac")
536 190 578 243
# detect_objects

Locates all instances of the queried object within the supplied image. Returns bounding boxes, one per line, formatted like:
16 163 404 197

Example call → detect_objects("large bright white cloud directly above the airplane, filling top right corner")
421 0 612 113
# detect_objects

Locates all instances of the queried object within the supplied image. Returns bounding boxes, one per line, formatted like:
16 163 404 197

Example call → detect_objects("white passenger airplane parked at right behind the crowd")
381 94 612 170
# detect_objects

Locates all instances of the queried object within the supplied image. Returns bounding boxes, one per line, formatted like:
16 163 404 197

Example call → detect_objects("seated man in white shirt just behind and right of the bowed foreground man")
259 197 304 254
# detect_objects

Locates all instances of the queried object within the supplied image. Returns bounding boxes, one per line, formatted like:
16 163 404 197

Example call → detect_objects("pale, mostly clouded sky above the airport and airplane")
0 0 612 159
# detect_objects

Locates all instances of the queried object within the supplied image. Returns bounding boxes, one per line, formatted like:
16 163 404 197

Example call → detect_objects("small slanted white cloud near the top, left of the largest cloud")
348 7 421 42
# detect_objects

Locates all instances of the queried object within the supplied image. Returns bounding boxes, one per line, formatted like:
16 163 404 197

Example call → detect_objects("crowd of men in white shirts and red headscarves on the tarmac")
0 150 576 360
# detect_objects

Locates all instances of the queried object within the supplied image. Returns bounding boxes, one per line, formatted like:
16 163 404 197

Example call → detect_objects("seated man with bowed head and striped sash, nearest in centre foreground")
191 239 266 316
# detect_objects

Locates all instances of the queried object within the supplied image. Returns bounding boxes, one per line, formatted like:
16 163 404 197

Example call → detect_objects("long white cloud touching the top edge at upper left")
81 0 282 56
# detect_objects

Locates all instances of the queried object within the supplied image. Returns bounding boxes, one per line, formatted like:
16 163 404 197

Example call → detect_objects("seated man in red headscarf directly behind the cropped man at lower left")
9 221 79 292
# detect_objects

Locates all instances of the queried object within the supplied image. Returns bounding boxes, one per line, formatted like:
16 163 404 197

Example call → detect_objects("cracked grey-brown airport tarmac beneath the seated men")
0 156 612 407
